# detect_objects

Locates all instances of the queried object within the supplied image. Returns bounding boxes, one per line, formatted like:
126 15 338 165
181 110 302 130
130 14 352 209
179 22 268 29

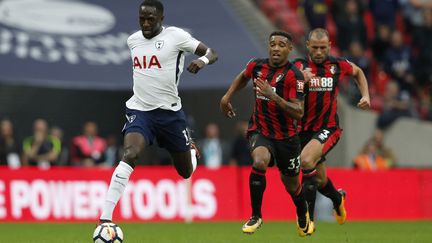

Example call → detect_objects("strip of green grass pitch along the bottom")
0 221 432 243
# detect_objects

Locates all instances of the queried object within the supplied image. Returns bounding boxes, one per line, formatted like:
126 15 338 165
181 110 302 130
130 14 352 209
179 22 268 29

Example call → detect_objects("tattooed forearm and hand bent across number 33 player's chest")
254 78 304 120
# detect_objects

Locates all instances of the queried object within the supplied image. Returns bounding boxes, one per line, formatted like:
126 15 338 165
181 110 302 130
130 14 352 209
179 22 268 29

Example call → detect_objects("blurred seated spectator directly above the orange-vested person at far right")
377 81 413 129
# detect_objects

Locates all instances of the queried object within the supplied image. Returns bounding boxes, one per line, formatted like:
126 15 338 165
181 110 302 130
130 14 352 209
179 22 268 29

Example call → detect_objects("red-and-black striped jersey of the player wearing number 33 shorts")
244 58 304 140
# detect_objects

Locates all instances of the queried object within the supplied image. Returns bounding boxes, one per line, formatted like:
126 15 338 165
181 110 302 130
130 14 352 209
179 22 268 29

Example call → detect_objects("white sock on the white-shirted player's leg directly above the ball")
100 161 133 220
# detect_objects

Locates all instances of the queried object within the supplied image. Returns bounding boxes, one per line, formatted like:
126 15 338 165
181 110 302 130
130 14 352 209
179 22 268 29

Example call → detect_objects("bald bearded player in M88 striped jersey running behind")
294 28 370 233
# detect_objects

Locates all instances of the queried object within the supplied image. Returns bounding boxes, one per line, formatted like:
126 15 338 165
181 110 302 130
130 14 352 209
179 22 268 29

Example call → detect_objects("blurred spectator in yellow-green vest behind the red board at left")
22 119 61 168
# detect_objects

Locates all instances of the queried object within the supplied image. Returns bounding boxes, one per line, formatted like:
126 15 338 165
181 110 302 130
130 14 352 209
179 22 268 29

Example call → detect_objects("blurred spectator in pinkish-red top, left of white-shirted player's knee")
70 121 106 167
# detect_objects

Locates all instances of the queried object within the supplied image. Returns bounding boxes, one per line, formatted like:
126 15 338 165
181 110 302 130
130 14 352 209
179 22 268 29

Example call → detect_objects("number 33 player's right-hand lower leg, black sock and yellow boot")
280 172 314 237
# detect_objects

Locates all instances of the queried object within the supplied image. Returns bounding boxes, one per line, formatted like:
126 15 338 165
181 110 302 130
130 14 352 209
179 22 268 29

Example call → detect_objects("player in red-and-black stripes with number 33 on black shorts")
220 31 310 236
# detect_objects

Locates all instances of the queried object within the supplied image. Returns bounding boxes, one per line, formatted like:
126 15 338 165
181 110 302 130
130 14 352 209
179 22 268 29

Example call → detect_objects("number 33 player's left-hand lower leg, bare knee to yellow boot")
242 146 271 234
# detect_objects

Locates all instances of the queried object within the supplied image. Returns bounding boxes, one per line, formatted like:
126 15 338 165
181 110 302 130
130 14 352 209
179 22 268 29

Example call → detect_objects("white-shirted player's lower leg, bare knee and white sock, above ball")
100 132 146 223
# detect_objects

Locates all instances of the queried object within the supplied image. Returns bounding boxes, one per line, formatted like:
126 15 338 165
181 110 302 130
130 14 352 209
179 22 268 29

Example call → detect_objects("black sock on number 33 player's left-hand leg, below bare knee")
249 168 266 218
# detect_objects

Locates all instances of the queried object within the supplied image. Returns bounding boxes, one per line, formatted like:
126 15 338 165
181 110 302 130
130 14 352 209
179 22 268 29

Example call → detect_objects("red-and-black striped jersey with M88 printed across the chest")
294 56 353 131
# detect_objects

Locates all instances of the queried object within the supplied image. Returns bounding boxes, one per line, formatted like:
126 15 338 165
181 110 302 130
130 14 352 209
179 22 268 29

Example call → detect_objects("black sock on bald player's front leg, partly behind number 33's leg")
302 169 317 221
